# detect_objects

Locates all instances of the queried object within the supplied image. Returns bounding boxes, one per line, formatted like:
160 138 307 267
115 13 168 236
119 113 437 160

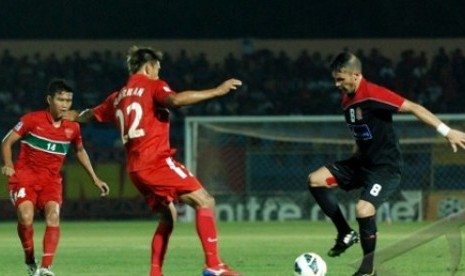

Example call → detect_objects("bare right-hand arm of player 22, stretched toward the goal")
165 79 242 107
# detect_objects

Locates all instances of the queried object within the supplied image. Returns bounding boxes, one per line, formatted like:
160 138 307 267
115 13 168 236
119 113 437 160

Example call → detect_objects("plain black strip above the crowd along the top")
0 0 465 39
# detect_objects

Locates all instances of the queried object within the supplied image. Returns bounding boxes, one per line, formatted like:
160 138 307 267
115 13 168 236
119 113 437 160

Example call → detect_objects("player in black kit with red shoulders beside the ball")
308 52 465 276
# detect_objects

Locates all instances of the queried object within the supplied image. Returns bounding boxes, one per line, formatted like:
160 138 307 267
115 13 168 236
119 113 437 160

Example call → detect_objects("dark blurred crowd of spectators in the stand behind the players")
0 48 465 125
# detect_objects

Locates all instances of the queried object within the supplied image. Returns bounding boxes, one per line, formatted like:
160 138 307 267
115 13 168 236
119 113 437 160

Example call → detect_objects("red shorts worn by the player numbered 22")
129 157 202 211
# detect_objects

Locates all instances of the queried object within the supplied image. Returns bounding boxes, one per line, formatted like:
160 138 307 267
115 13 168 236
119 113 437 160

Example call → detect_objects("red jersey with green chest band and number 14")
12 110 82 181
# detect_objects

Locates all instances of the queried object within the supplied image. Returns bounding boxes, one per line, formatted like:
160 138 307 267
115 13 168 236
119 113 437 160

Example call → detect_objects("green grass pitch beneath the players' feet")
0 219 465 276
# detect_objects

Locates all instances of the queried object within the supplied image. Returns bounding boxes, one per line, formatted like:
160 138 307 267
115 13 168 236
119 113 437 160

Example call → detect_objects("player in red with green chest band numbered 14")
2 79 109 276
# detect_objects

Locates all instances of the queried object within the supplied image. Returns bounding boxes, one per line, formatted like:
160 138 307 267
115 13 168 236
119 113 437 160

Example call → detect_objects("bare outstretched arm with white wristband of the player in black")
399 100 465 152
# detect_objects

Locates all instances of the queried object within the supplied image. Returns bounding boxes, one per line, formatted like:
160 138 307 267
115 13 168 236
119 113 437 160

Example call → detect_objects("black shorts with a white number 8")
326 158 401 208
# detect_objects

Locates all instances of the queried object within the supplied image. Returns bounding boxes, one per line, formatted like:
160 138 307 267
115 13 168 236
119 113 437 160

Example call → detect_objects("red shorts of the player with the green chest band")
8 175 63 210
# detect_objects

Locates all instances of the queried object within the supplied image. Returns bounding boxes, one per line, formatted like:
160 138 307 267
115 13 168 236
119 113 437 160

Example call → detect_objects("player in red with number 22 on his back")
67 46 241 276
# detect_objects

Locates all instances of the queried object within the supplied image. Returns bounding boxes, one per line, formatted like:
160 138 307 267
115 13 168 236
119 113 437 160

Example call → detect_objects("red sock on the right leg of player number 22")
195 208 221 267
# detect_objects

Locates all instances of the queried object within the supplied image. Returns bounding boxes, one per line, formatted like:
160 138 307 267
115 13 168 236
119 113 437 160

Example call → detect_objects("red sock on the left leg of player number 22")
150 221 173 276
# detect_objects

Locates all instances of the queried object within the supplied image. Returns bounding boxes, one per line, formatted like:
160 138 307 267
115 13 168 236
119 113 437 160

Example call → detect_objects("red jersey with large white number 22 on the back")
93 74 176 172
